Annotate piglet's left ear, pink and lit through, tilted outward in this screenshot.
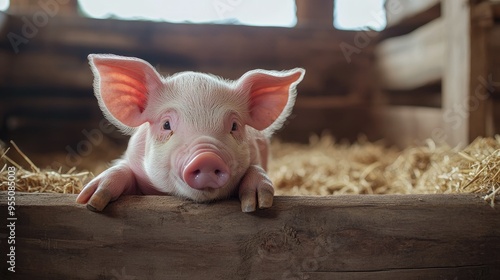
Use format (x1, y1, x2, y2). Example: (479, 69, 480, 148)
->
(88, 54, 162, 130)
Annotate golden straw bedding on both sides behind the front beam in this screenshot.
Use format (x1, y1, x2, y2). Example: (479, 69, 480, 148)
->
(0, 135, 500, 205)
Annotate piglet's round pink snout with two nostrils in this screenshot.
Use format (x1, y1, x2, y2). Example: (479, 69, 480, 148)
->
(182, 152, 230, 190)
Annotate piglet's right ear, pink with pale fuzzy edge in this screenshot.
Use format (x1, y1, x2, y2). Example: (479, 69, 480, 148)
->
(238, 68, 305, 133)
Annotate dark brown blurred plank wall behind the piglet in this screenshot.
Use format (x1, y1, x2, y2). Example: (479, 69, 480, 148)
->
(0, 0, 378, 168)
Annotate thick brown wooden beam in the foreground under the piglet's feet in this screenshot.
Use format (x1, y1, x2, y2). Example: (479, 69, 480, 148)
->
(0, 193, 500, 279)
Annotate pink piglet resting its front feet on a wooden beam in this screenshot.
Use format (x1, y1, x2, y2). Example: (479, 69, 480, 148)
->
(76, 54, 305, 212)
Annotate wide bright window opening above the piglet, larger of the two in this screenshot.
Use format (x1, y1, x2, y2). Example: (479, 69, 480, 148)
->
(78, 0, 297, 27)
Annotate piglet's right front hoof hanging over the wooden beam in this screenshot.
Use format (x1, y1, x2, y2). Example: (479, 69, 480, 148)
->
(239, 166, 274, 213)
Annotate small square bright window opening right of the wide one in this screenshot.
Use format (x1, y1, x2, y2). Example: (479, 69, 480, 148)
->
(333, 0, 387, 31)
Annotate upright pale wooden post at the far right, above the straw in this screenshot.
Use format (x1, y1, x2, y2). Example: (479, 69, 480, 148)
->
(443, 0, 492, 146)
